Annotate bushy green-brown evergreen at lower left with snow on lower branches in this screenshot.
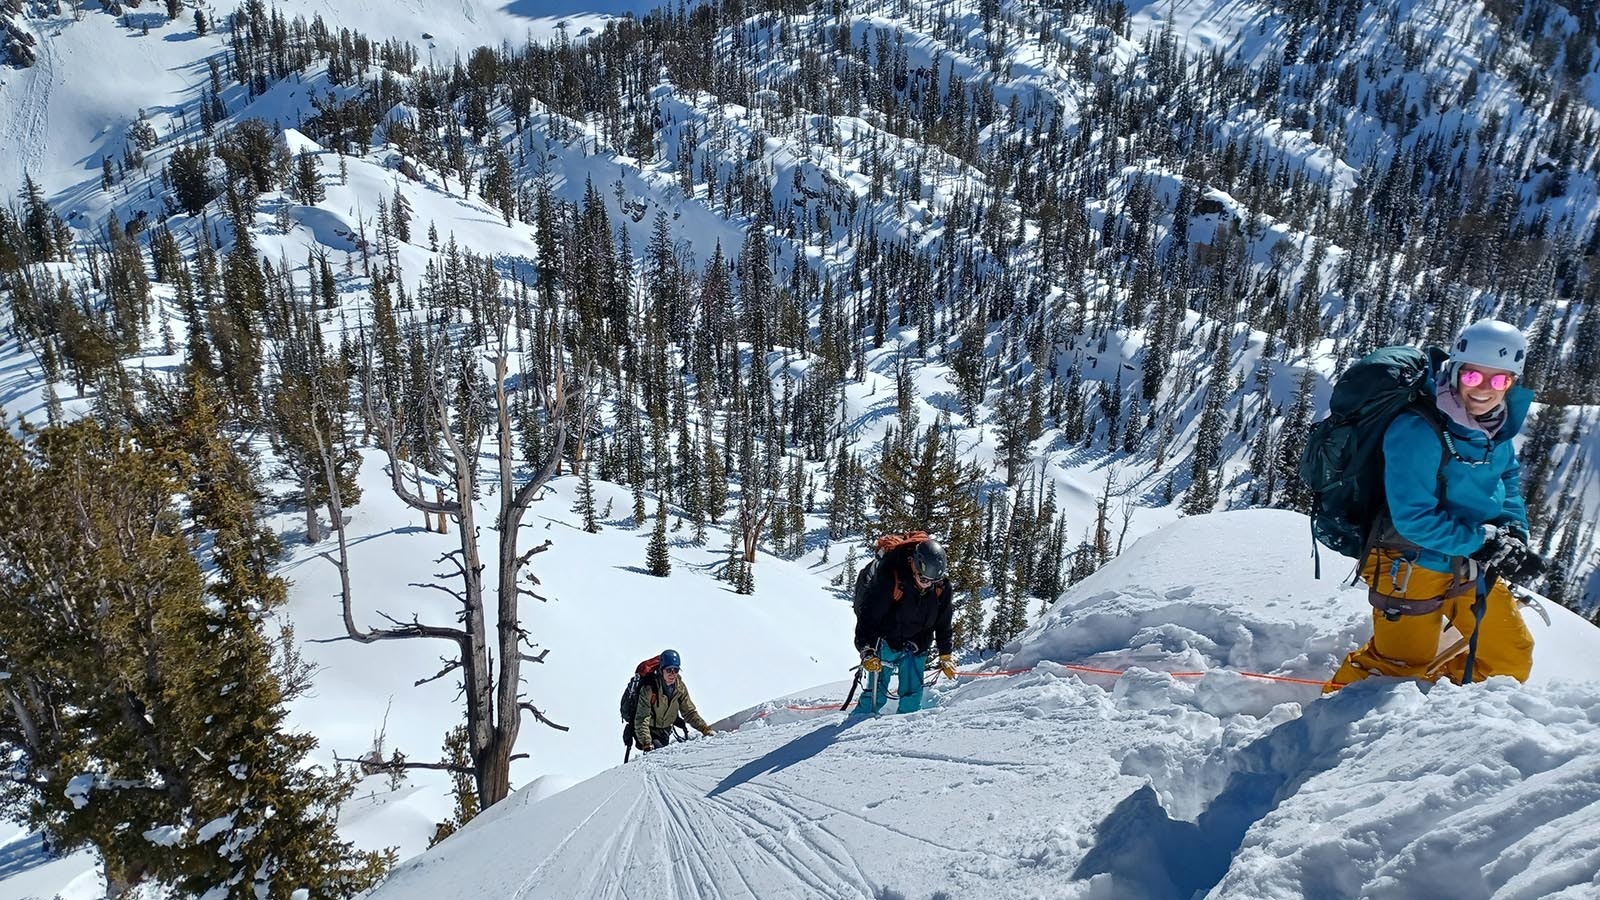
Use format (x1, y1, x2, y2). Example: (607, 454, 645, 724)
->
(0, 421, 386, 900)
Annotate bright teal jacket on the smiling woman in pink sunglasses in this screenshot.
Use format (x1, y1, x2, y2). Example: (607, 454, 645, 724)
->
(1384, 351, 1533, 572)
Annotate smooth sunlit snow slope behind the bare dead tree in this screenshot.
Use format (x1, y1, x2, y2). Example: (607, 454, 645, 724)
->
(283, 453, 856, 813)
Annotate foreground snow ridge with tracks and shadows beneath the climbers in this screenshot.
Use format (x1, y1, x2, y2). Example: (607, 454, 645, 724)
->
(360, 511, 1600, 900)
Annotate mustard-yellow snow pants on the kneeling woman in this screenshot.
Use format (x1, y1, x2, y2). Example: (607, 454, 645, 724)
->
(1323, 551, 1533, 692)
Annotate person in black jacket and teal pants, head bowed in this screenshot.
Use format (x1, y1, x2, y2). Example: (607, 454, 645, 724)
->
(856, 536, 955, 714)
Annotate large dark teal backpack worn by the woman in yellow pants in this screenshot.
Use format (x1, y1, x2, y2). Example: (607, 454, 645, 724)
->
(1299, 348, 1448, 566)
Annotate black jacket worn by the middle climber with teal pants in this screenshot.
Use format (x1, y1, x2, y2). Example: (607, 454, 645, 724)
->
(856, 544, 955, 653)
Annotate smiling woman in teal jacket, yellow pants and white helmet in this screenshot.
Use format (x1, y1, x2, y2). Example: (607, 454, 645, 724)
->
(1330, 319, 1542, 687)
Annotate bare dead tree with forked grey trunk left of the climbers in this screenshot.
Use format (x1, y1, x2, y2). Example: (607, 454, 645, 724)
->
(312, 309, 592, 809)
